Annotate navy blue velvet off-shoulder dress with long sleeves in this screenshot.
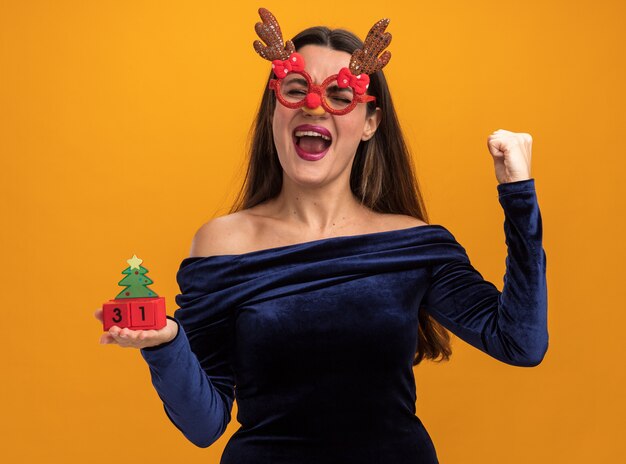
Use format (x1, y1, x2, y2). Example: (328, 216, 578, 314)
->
(141, 179, 548, 464)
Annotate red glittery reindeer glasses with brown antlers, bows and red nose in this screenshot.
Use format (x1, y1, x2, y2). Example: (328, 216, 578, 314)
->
(254, 8, 391, 115)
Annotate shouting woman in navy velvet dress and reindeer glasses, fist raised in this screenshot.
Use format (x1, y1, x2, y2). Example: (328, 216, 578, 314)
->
(94, 10, 548, 464)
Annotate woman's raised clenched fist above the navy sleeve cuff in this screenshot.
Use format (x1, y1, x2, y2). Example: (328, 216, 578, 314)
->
(487, 129, 533, 184)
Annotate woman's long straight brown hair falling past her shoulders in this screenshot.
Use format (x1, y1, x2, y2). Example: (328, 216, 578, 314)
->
(230, 27, 452, 365)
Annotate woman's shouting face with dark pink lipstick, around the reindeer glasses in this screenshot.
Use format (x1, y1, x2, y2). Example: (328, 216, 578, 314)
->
(272, 45, 380, 186)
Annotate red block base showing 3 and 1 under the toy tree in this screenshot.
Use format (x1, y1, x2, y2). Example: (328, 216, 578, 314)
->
(102, 297, 167, 331)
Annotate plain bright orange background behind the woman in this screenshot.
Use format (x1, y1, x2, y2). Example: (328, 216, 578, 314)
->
(0, 0, 626, 464)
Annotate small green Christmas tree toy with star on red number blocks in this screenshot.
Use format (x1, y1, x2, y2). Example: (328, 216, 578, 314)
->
(102, 255, 166, 331)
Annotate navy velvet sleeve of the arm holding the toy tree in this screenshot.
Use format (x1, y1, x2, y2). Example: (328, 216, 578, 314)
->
(141, 270, 235, 448)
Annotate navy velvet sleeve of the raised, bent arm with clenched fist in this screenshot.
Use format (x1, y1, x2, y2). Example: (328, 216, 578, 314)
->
(423, 179, 548, 367)
